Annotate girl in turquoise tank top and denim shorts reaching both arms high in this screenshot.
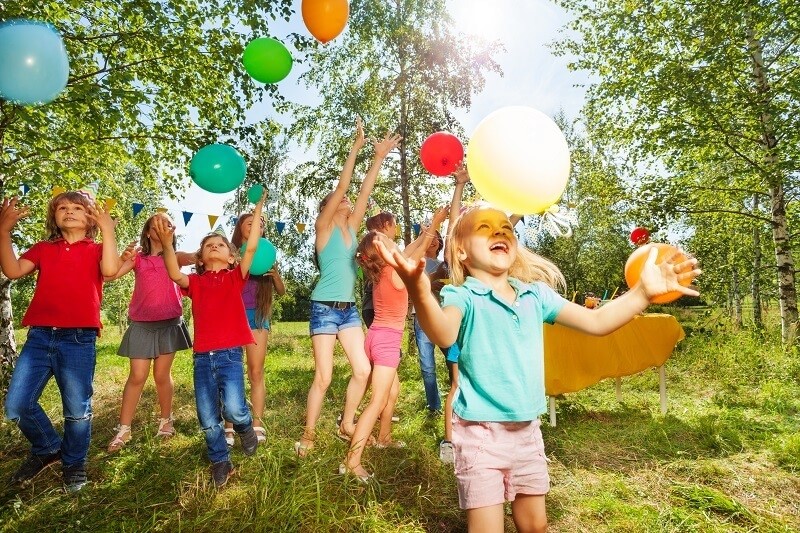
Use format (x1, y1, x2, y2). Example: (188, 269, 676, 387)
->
(294, 119, 401, 457)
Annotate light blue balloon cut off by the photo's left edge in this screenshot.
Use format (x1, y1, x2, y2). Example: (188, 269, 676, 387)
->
(0, 20, 69, 105)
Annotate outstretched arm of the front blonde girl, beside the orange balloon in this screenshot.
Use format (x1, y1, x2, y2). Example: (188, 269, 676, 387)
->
(556, 246, 701, 335)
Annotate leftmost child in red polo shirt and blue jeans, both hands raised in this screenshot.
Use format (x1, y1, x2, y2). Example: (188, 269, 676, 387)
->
(0, 191, 121, 492)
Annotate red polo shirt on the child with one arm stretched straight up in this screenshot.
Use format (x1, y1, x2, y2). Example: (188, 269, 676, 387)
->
(181, 265, 255, 352)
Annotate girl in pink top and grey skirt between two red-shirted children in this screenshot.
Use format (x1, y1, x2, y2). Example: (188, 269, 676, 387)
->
(108, 213, 194, 453)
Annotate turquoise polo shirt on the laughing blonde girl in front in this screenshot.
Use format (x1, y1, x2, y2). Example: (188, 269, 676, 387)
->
(442, 277, 567, 422)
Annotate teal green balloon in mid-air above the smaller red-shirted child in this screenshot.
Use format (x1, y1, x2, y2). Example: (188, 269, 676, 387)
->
(189, 144, 247, 193)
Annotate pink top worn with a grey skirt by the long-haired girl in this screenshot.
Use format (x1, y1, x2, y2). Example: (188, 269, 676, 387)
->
(128, 254, 183, 322)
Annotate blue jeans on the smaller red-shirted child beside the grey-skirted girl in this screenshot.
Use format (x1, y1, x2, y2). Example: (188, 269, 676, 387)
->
(194, 347, 253, 463)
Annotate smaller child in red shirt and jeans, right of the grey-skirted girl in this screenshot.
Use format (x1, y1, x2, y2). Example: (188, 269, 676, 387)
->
(153, 196, 264, 488)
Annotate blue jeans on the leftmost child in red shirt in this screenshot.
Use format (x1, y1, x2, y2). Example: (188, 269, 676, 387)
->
(5, 327, 97, 467)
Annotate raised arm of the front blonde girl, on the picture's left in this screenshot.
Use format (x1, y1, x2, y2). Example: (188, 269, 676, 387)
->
(375, 240, 461, 346)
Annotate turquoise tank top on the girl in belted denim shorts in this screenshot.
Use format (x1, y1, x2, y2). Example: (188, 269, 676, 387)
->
(311, 227, 358, 302)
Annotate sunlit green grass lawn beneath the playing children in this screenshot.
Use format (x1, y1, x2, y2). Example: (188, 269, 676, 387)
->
(0, 313, 800, 532)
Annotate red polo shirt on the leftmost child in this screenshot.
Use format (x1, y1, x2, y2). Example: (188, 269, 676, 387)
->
(20, 238, 103, 329)
